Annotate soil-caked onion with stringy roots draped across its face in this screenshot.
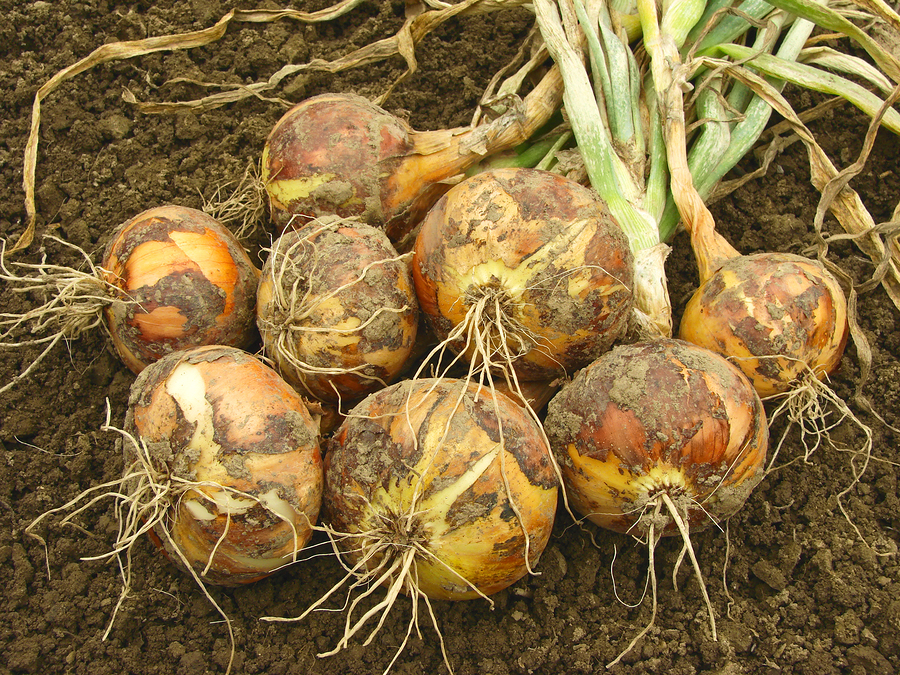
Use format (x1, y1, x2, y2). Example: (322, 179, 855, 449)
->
(256, 221, 419, 403)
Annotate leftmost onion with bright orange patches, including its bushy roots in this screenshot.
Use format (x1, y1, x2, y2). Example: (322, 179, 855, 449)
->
(0, 205, 259, 391)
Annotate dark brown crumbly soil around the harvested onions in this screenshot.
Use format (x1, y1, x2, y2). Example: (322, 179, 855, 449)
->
(0, 0, 900, 675)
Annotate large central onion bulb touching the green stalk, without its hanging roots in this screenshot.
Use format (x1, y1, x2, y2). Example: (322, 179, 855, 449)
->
(413, 169, 634, 380)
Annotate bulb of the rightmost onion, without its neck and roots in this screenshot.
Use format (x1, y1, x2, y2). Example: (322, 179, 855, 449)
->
(679, 253, 849, 398)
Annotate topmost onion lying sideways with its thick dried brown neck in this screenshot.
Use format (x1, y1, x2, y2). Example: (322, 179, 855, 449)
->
(261, 83, 560, 242)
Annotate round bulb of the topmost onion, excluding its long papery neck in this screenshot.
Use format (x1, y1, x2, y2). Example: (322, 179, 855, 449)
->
(262, 94, 412, 240)
